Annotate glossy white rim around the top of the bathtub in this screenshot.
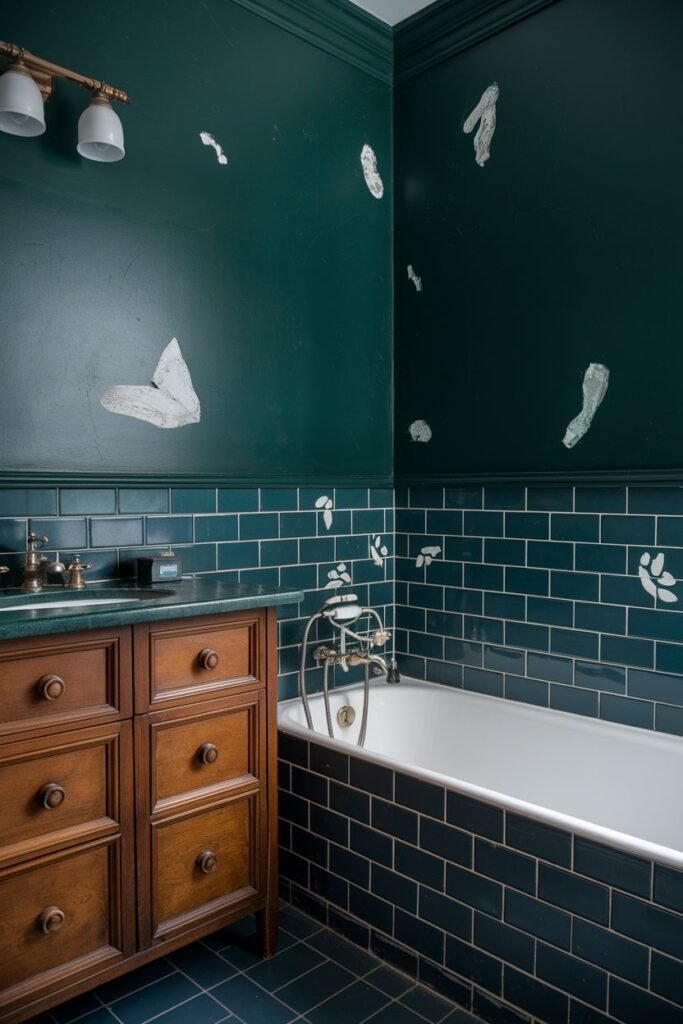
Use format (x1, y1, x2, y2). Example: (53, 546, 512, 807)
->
(278, 676, 683, 870)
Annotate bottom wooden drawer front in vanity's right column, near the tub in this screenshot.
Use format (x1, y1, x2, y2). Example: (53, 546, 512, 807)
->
(152, 794, 261, 938)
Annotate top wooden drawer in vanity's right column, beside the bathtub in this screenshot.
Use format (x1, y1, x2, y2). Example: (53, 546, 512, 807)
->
(135, 612, 265, 713)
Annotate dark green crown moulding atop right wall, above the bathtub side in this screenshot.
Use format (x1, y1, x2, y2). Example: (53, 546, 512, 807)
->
(394, 0, 555, 83)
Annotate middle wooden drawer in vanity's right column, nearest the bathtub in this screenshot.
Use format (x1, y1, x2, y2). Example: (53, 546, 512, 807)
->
(142, 689, 265, 814)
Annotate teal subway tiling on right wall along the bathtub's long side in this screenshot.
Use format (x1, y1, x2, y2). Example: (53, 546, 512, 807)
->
(396, 486, 683, 735)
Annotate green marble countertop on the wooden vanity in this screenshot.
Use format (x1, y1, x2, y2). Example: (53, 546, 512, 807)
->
(0, 578, 303, 640)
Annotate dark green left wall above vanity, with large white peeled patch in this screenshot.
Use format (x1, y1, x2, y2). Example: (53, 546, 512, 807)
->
(0, 0, 392, 482)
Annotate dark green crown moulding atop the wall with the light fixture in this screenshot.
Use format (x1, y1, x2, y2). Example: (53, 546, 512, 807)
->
(229, 0, 393, 84)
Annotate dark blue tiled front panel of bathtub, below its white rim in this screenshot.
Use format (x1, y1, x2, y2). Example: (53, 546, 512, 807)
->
(281, 733, 683, 1024)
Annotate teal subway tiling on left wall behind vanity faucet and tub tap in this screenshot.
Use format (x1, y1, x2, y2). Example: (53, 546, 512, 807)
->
(0, 487, 394, 696)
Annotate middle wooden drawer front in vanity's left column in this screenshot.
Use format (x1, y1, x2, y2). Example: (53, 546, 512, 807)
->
(0, 722, 132, 863)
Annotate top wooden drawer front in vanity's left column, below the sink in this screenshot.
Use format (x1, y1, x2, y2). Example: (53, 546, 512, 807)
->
(0, 630, 132, 736)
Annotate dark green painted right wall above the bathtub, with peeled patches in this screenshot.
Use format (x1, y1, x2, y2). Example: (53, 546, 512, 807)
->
(394, 0, 683, 479)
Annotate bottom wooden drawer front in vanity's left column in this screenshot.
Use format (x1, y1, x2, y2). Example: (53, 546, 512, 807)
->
(0, 839, 128, 1008)
